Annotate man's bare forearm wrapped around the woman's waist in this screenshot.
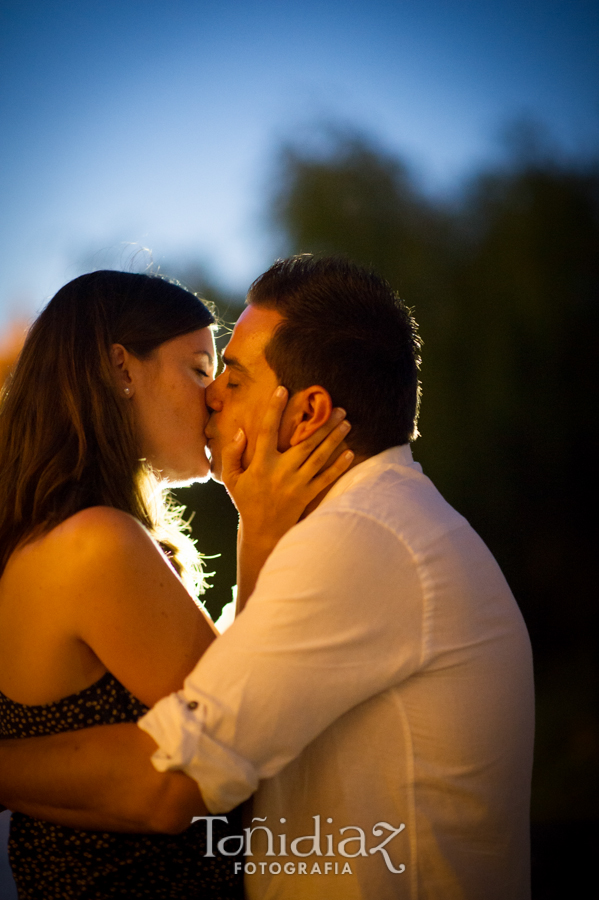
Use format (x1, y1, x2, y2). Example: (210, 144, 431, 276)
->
(0, 723, 209, 833)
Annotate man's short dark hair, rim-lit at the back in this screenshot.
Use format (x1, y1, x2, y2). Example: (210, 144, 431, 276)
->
(247, 254, 421, 456)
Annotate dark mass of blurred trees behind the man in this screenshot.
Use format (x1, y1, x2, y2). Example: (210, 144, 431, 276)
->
(271, 128, 599, 836)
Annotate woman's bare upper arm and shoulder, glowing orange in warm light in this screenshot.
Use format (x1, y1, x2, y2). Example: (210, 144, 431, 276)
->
(30, 507, 216, 706)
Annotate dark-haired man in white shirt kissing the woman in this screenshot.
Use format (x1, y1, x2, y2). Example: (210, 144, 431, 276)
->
(0, 256, 533, 900)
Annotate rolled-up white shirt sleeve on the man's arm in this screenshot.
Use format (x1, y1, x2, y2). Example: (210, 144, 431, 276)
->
(139, 507, 423, 813)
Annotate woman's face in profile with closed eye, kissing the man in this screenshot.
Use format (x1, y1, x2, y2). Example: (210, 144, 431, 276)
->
(123, 328, 216, 484)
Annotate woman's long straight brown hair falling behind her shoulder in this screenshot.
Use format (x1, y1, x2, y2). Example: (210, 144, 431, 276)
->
(0, 271, 215, 592)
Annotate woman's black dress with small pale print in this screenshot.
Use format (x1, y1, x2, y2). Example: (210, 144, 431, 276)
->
(0, 672, 243, 900)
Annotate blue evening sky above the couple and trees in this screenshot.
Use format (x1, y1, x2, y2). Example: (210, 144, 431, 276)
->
(0, 0, 599, 320)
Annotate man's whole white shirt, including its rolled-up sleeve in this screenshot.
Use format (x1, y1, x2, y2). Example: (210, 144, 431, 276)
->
(139, 445, 534, 900)
